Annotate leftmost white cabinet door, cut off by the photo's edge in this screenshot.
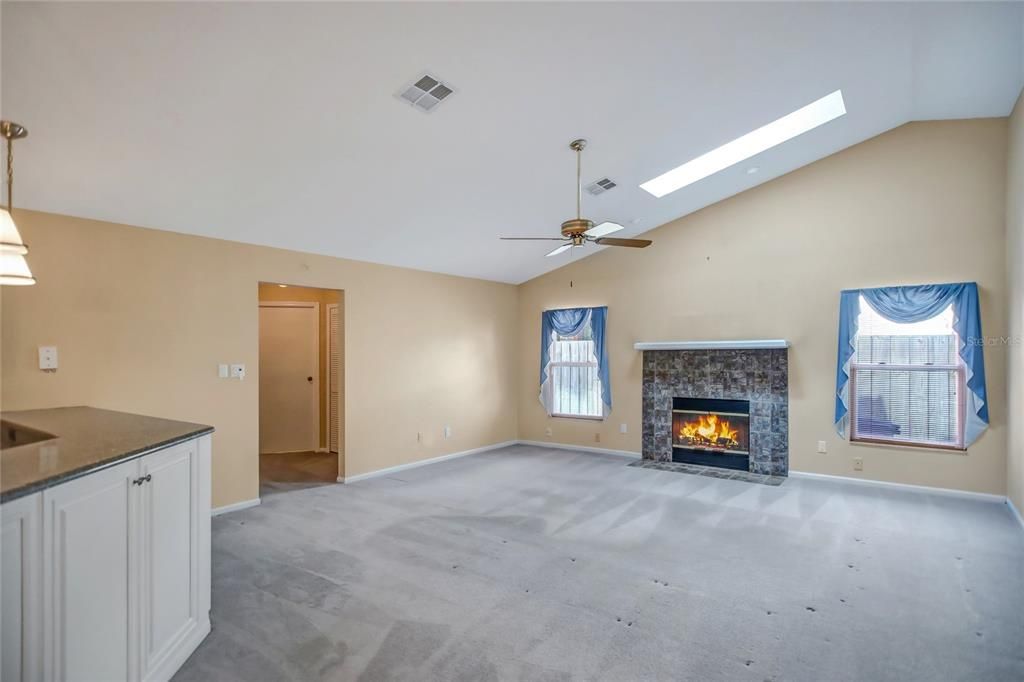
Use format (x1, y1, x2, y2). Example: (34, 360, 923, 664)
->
(0, 493, 43, 682)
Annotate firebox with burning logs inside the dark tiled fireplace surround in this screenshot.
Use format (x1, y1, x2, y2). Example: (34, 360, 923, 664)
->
(672, 397, 751, 471)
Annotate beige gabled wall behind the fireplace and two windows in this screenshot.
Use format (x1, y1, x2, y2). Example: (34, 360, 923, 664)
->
(518, 119, 1008, 494)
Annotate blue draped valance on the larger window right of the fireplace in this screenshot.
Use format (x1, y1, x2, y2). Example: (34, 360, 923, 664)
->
(835, 282, 988, 446)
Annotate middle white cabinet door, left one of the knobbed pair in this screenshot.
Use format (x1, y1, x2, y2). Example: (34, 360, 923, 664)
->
(43, 460, 139, 680)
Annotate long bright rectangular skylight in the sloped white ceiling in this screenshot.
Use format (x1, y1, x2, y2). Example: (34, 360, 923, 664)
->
(640, 90, 846, 199)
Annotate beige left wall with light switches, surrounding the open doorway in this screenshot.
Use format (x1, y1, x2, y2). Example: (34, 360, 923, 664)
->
(0, 210, 517, 506)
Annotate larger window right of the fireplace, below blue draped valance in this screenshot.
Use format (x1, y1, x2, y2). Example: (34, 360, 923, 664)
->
(850, 296, 965, 450)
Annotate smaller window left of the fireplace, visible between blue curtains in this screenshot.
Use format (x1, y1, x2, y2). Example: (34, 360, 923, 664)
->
(549, 323, 604, 419)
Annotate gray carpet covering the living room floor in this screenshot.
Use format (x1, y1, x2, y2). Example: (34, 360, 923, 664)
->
(175, 445, 1024, 682)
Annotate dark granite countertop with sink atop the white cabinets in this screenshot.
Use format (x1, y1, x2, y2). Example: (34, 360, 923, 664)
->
(0, 407, 213, 502)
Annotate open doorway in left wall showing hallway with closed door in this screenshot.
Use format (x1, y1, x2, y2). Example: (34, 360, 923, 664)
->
(259, 283, 344, 494)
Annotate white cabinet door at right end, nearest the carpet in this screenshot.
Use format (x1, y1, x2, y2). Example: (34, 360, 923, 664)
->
(139, 440, 205, 680)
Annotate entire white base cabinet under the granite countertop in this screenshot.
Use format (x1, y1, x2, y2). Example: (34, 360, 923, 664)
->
(0, 435, 210, 682)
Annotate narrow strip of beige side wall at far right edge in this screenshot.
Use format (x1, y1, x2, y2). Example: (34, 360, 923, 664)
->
(1007, 92, 1024, 503)
